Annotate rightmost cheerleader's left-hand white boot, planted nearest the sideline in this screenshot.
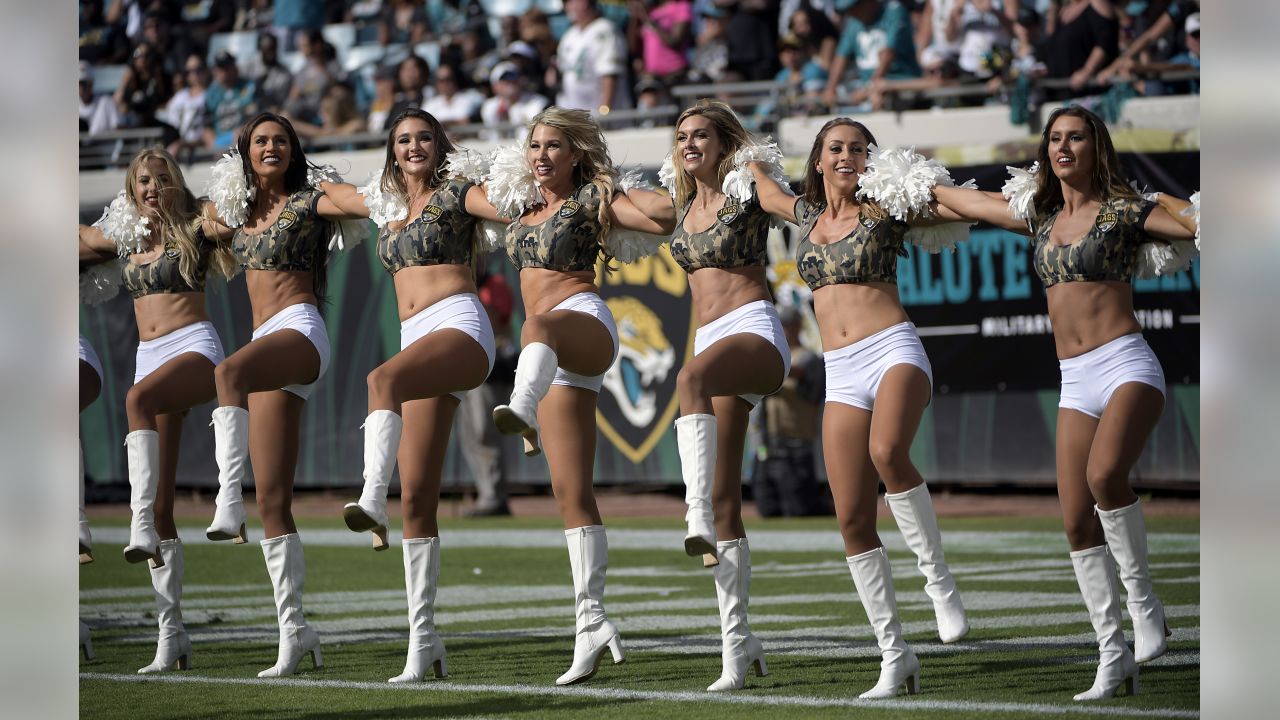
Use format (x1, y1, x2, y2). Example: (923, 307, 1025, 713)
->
(1071, 544, 1138, 701)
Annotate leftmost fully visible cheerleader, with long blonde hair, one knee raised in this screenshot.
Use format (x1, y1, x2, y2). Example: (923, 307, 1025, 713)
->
(79, 149, 233, 674)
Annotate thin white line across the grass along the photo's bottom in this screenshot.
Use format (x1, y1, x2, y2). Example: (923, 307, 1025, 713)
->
(79, 673, 1199, 719)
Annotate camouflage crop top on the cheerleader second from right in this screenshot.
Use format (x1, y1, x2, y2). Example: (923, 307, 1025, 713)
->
(795, 199, 910, 290)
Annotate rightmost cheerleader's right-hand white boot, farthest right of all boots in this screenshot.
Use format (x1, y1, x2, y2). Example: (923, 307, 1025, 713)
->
(1097, 500, 1170, 662)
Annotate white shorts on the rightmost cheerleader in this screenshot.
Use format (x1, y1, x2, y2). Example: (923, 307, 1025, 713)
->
(1057, 333, 1165, 418)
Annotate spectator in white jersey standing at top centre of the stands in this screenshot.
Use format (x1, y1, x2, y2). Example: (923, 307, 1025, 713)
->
(556, 0, 631, 115)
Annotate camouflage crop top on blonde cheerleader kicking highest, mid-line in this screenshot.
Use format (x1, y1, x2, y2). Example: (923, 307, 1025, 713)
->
(507, 183, 600, 273)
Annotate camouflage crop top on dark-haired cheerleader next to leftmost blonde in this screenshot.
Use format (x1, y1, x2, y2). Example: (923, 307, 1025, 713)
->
(232, 187, 332, 272)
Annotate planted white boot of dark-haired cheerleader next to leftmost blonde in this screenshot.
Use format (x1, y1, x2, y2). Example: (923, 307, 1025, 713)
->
(257, 533, 324, 678)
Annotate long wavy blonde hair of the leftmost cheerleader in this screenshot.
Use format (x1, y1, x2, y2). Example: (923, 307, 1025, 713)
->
(124, 147, 236, 280)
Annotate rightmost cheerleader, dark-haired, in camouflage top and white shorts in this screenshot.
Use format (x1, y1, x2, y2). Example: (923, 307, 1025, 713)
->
(934, 106, 1199, 701)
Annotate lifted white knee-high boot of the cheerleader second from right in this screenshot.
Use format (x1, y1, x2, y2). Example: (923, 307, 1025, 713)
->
(884, 483, 969, 643)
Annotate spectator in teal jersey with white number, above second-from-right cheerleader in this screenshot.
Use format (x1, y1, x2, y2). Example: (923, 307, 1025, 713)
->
(823, 0, 920, 106)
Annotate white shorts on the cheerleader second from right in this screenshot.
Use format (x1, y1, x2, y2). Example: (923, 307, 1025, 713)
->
(822, 323, 933, 410)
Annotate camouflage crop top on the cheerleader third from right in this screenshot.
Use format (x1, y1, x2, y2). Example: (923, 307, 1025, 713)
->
(671, 197, 772, 273)
